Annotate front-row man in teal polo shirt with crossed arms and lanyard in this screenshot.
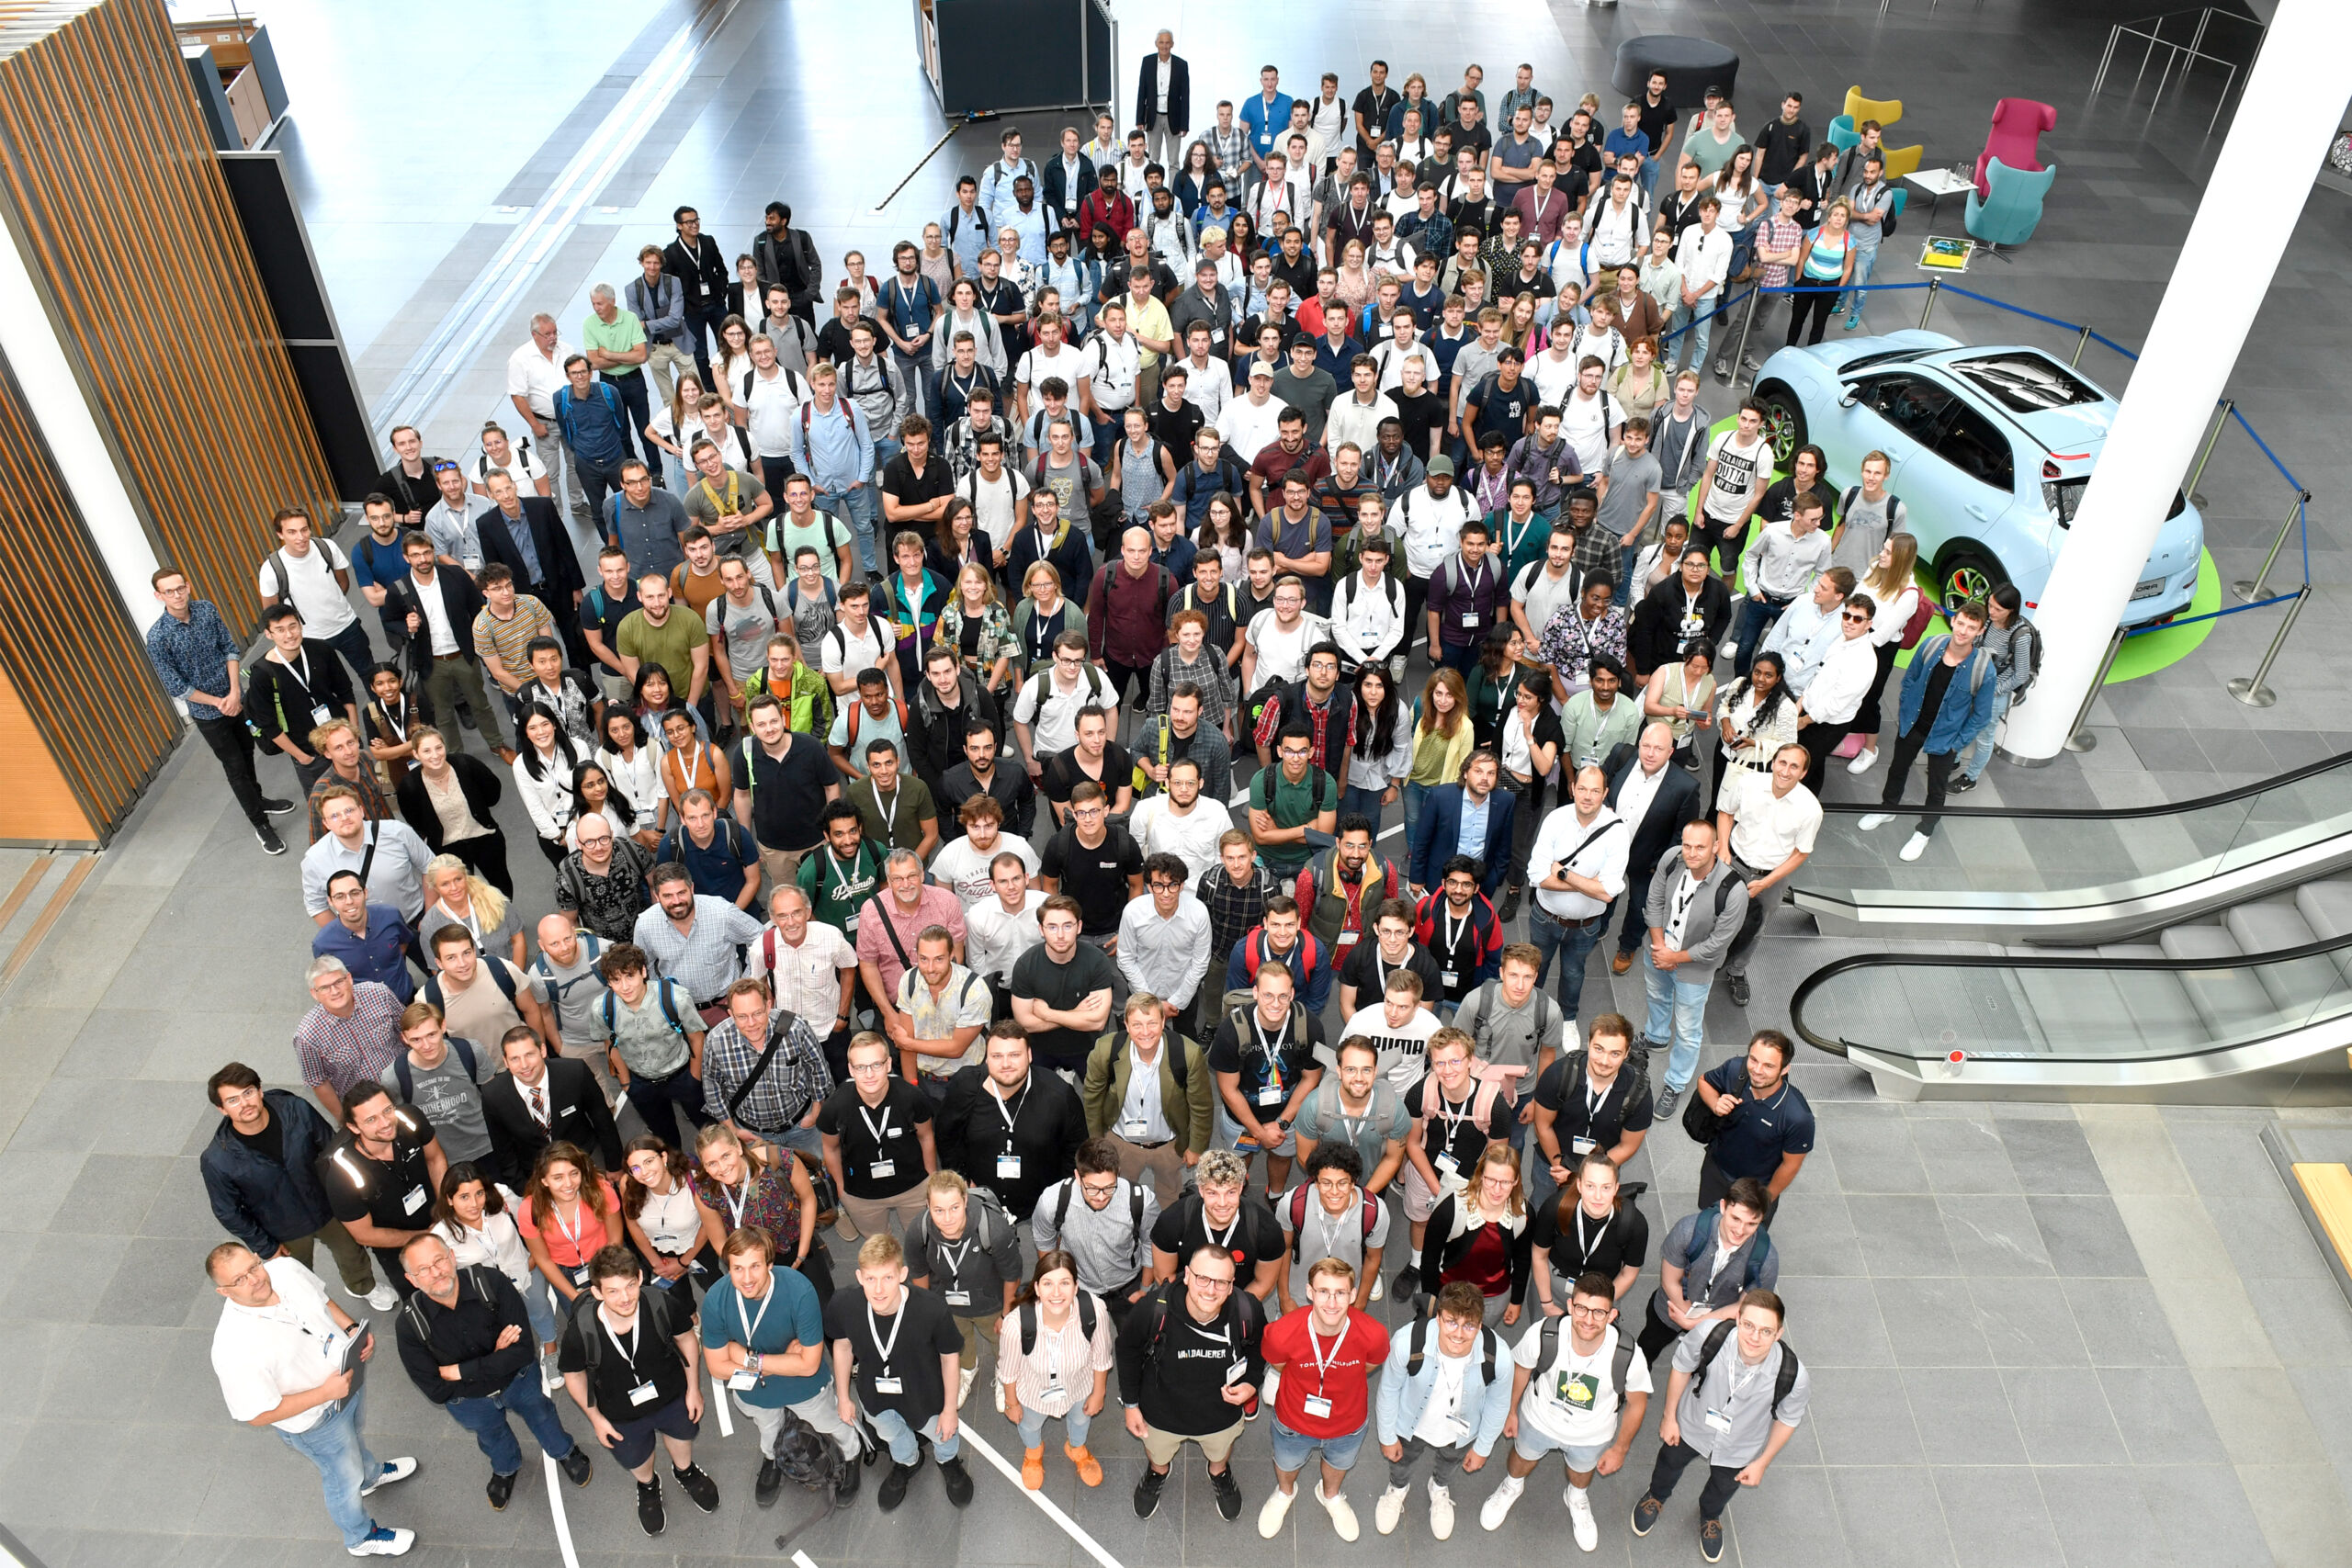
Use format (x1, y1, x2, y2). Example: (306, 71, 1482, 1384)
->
(701, 1224, 864, 1506)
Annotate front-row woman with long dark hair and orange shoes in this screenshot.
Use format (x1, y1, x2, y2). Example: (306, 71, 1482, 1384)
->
(997, 1246, 1117, 1493)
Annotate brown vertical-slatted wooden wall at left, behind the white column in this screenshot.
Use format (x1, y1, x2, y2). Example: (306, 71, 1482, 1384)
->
(0, 0, 336, 837)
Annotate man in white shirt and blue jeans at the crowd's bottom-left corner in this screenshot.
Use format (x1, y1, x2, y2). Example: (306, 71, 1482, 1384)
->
(205, 1241, 416, 1556)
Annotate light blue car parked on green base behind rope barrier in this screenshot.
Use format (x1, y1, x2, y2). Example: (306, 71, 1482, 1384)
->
(1757, 332, 2204, 626)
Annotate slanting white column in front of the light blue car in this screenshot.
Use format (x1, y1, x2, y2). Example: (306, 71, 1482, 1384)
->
(2004, 0, 2352, 761)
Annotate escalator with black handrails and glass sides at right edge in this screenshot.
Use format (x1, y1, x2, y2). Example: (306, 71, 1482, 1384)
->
(1790, 757, 2352, 1105)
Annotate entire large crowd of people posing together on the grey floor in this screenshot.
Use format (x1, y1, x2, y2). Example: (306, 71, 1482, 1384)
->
(148, 33, 2034, 1561)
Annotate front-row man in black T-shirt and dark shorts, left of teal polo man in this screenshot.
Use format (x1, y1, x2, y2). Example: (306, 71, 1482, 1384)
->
(555, 1244, 719, 1535)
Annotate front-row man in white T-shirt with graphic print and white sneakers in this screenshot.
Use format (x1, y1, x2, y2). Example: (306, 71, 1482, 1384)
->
(1477, 1274, 1672, 1551)
